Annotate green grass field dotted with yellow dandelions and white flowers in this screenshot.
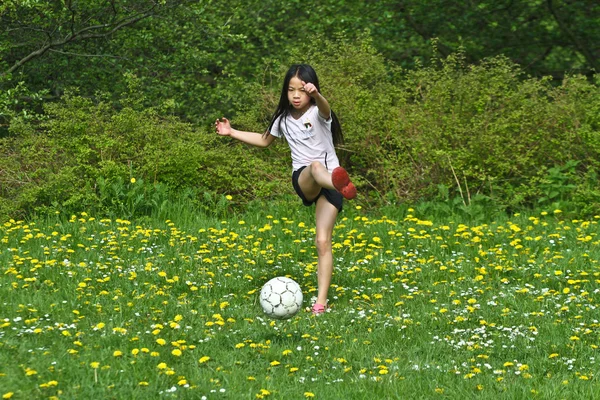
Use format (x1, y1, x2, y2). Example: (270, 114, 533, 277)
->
(0, 205, 600, 399)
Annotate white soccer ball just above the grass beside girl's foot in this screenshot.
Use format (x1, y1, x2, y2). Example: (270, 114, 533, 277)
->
(260, 276, 303, 319)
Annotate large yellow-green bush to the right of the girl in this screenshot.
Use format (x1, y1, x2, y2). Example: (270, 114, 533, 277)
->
(274, 37, 600, 212)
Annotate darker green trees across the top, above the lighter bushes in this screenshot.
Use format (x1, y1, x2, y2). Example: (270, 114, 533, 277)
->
(0, 0, 600, 127)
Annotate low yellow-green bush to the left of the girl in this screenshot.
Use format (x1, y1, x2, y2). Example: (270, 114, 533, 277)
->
(0, 85, 290, 222)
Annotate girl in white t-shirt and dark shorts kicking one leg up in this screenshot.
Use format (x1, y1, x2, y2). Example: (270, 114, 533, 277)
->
(215, 64, 356, 315)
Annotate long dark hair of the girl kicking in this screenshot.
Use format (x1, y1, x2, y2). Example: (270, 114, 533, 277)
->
(269, 64, 344, 145)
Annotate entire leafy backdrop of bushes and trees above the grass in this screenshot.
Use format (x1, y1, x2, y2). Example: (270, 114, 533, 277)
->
(0, 0, 600, 219)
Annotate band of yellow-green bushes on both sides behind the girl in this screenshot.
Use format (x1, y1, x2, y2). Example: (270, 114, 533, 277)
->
(0, 35, 600, 222)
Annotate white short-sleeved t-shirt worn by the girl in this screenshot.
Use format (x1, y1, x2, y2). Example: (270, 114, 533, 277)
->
(269, 104, 340, 172)
